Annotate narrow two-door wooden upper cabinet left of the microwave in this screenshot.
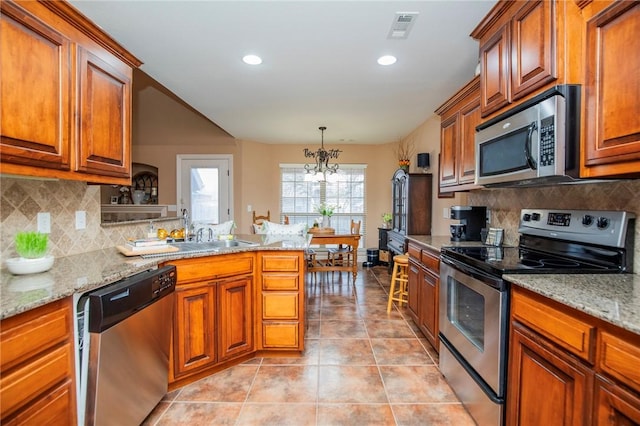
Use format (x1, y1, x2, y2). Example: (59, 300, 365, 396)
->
(436, 77, 480, 192)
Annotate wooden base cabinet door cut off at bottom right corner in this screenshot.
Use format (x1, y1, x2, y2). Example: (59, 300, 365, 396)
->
(593, 378, 640, 426)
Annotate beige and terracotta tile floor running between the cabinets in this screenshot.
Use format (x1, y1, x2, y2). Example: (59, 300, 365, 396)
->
(144, 266, 474, 426)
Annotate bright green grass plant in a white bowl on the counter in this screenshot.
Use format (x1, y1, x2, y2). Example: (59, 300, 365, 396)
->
(6, 231, 54, 275)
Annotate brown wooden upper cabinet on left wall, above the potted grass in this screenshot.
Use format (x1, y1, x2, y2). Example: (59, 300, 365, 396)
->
(0, 0, 141, 184)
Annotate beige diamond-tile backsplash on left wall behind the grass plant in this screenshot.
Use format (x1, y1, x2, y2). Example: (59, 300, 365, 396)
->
(0, 177, 178, 265)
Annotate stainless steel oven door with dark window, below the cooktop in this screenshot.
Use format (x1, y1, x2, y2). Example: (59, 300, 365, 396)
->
(439, 258, 508, 398)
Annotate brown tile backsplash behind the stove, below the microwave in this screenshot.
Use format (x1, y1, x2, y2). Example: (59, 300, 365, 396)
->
(467, 179, 640, 273)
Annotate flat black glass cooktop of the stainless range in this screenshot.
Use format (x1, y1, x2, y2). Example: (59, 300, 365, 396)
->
(442, 246, 619, 274)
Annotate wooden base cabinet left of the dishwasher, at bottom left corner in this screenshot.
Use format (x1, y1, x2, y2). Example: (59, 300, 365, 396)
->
(0, 298, 77, 425)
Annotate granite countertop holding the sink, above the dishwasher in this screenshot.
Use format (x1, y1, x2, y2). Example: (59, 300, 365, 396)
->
(0, 235, 307, 319)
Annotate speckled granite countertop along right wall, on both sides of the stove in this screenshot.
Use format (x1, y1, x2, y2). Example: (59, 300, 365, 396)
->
(407, 235, 640, 334)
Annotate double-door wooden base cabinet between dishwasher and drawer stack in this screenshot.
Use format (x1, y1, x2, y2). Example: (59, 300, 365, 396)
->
(169, 253, 255, 388)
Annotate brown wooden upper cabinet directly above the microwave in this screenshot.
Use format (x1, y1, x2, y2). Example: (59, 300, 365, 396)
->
(471, 0, 581, 118)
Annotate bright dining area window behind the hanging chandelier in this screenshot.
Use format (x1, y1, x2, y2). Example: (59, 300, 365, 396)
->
(280, 164, 367, 235)
